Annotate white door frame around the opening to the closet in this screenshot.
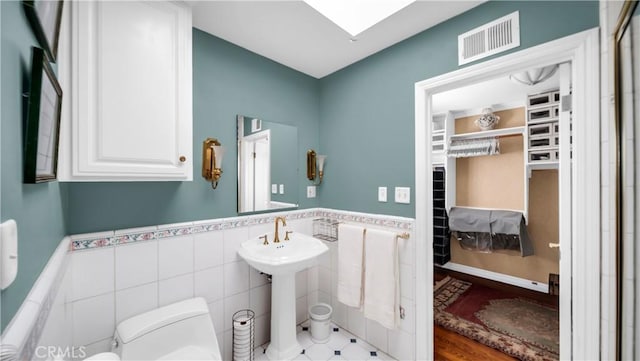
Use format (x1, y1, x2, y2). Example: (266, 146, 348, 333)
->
(415, 28, 601, 360)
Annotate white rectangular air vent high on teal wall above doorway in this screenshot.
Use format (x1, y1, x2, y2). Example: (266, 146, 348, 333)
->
(458, 11, 520, 65)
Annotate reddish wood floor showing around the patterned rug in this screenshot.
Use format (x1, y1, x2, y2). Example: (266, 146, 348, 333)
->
(433, 267, 558, 361)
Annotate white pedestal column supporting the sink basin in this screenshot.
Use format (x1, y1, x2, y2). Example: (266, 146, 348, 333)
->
(267, 272, 302, 360)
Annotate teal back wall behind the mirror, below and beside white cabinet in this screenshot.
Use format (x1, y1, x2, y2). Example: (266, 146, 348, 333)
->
(67, 29, 320, 234)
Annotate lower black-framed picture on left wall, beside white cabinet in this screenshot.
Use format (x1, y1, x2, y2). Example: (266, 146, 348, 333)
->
(24, 47, 62, 183)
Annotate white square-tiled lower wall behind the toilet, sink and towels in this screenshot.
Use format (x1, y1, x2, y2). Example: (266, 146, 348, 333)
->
(28, 210, 415, 359)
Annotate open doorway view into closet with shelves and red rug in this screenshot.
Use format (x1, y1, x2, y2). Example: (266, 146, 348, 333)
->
(432, 63, 571, 359)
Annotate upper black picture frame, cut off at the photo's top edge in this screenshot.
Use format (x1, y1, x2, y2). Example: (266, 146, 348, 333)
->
(22, 0, 63, 63)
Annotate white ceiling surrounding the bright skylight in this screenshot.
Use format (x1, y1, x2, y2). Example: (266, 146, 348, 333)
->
(187, 0, 486, 78)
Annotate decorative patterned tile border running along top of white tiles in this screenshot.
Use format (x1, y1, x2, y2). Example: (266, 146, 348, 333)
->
(69, 208, 415, 252)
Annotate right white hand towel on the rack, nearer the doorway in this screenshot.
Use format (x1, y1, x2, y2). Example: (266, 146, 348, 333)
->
(364, 229, 400, 330)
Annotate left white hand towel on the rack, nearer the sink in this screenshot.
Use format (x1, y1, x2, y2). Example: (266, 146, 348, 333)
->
(338, 223, 364, 308)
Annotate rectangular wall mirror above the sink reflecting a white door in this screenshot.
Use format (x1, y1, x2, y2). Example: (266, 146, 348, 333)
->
(236, 115, 298, 213)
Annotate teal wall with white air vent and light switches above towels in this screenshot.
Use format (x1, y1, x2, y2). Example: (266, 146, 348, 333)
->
(318, 1, 599, 217)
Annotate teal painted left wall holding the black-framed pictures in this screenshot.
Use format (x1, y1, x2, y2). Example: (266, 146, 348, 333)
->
(0, 1, 67, 330)
